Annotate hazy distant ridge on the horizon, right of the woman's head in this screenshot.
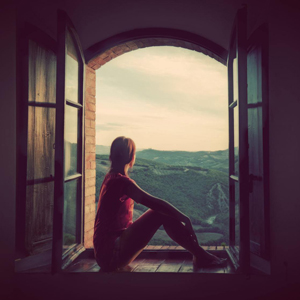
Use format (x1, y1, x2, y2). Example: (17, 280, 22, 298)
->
(136, 149, 228, 173)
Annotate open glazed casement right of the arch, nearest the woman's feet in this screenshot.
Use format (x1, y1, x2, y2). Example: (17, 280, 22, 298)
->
(227, 7, 250, 273)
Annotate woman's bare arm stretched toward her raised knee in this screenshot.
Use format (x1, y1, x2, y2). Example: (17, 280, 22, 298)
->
(126, 182, 189, 223)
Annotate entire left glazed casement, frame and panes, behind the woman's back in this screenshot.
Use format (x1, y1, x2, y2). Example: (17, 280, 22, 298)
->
(52, 11, 85, 272)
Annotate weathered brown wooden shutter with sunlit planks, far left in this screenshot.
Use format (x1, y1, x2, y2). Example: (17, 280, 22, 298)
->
(16, 24, 56, 257)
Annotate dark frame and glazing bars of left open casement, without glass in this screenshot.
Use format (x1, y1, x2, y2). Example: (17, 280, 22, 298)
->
(52, 10, 85, 273)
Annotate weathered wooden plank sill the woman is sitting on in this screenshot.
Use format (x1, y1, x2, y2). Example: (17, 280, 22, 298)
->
(65, 246, 234, 274)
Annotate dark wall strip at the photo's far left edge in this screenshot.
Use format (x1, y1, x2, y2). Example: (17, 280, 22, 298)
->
(0, 5, 16, 299)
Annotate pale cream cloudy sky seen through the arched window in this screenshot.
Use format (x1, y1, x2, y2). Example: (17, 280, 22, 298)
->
(96, 46, 228, 151)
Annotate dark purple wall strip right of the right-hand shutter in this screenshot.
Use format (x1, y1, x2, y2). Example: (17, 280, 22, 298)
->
(269, 1, 300, 277)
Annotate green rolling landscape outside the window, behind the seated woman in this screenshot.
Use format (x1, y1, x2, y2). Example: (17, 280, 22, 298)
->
(96, 145, 233, 245)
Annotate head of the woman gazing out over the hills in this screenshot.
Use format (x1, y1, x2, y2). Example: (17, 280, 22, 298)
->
(109, 136, 135, 173)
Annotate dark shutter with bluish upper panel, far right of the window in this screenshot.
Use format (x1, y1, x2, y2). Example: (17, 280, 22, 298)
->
(247, 25, 270, 273)
